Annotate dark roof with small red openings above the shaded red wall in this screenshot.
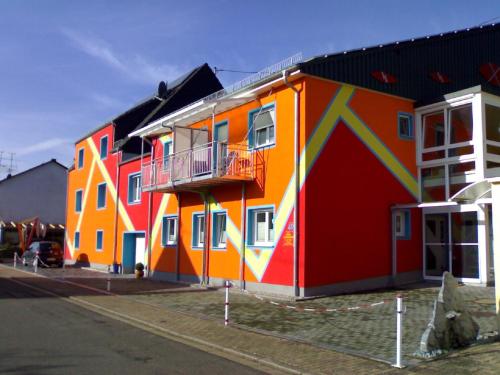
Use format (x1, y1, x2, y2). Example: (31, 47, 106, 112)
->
(298, 24, 500, 104)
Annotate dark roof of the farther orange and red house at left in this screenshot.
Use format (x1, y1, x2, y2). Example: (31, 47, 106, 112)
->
(75, 63, 222, 146)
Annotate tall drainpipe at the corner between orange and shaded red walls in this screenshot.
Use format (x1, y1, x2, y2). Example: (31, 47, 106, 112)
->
(283, 70, 300, 297)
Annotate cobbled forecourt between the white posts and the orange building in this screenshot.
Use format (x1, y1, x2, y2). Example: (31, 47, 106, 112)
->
(1, 262, 500, 372)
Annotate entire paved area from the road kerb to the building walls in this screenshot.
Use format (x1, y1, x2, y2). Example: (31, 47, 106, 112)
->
(0, 265, 500, 375)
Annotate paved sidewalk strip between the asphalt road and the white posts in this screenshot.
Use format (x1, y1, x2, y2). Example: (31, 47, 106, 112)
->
(0, 267, 500, 374)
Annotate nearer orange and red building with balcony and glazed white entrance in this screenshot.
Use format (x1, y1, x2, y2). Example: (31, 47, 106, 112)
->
(68, 25, 500, 296)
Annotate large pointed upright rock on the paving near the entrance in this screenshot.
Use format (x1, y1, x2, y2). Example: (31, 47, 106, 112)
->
(420, 272, 479, 356)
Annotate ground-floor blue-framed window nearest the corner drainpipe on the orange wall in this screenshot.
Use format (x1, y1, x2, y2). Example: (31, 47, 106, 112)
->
(248, 208, 274, 246)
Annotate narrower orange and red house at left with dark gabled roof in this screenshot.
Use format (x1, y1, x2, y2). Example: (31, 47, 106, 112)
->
(65, 64, 222, 272)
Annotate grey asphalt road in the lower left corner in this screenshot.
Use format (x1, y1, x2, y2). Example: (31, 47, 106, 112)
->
(0, 278, 264, 375)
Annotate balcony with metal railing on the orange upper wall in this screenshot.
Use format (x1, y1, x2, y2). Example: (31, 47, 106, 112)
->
(142, 142, 255, 193)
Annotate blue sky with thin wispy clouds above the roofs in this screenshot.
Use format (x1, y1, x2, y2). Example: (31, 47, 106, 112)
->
(0, 0, 500, 177)
